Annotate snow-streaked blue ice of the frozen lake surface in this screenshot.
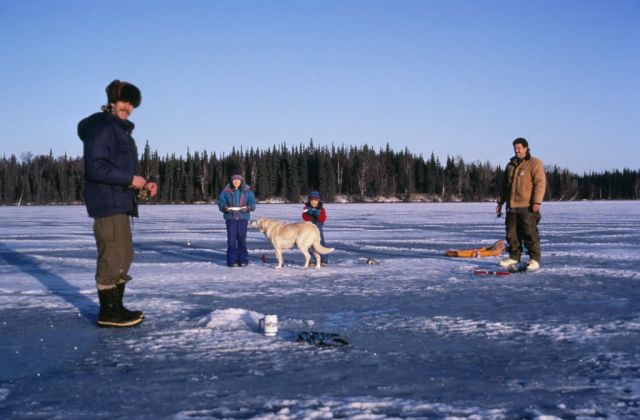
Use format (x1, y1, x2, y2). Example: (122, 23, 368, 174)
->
(0, 201, 640, 419)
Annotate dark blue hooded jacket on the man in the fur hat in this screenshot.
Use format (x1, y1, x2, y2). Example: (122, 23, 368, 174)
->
(78, 111, 138, 217)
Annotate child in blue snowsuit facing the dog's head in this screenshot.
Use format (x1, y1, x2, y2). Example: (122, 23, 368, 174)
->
(218, 174, 256, 267)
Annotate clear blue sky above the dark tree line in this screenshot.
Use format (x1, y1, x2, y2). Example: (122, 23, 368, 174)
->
(0, 0, 640, 173)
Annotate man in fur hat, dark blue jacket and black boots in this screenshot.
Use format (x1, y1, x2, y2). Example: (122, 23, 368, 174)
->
(78, 80, 158, 327)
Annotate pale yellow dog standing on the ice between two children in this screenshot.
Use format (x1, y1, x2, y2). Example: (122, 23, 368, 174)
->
(251, 217, 333, 269)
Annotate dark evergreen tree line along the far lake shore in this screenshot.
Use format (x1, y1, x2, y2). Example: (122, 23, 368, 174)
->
(0, 140, 640, 205)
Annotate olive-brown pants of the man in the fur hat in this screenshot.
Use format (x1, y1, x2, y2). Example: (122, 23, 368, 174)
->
(93, 214, 133, 290)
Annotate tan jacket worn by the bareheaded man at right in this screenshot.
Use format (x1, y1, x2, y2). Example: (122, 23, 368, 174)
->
(500, 156, 547, 209)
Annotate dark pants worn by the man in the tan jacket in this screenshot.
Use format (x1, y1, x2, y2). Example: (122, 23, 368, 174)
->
(506, 209, 542, 262)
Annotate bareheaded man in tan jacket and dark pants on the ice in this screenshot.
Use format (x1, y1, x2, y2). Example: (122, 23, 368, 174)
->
(496, 137, 546, 271)
